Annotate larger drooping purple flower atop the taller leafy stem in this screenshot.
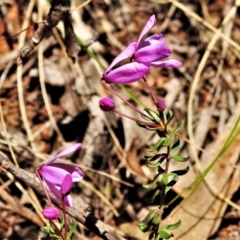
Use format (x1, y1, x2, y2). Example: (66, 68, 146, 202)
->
(103, 15, 182, 84)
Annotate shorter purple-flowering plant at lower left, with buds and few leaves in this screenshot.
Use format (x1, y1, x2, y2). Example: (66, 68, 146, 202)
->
(36, 143, 83, 240)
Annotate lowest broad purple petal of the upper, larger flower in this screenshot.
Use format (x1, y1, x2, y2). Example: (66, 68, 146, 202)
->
(103, 62, 149, 84)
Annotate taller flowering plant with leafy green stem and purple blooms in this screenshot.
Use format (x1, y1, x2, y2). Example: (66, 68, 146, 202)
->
(99, 15, 189, 240)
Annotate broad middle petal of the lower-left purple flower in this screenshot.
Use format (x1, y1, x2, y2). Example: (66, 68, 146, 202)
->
(40, 163, 83, 186)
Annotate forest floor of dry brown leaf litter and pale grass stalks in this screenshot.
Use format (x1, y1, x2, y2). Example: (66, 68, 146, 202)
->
(0, 0, 240, 240)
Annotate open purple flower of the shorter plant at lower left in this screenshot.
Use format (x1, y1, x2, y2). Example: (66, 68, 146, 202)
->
(39, 143, 83, 207)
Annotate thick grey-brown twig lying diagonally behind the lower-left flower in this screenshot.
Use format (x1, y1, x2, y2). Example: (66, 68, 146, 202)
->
(0, 152, 126, 240)
